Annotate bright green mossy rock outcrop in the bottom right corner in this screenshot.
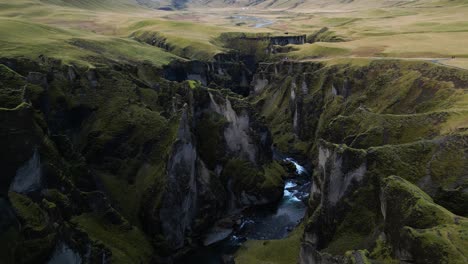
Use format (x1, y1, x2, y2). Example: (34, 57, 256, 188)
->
(380, 176, 468, 263)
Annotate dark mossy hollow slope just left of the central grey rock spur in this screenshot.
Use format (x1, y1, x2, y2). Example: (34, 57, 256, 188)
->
(81, 94, 177, 225)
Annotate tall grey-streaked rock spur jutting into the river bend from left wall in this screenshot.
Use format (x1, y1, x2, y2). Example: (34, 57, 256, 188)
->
(159, 90, 282, 250)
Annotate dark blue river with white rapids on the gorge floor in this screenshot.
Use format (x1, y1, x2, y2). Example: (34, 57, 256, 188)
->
(176, 157, 311, 264)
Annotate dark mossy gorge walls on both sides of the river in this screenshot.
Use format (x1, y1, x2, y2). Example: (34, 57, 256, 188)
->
(0, 42, 468, 264)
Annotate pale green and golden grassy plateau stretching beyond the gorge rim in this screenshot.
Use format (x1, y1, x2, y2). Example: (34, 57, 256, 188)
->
(0, 0, 468, 68)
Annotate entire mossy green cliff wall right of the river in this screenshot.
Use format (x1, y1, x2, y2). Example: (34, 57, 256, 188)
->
(252, 61, 468, 263)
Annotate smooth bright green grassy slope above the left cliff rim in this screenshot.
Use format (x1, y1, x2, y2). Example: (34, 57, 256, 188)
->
(0, 18, 176, 67)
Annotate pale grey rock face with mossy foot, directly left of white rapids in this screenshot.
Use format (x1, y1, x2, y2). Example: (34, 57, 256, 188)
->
(209, 92, 282, 209)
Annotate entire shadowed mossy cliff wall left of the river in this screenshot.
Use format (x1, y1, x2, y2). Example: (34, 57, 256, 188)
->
(0, 55, 285, 263)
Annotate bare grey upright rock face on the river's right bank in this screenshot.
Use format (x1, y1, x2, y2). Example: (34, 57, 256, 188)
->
(300, 141, 367, 264)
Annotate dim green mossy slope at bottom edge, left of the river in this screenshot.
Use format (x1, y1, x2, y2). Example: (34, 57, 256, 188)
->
(72, 214, 153, 263)
